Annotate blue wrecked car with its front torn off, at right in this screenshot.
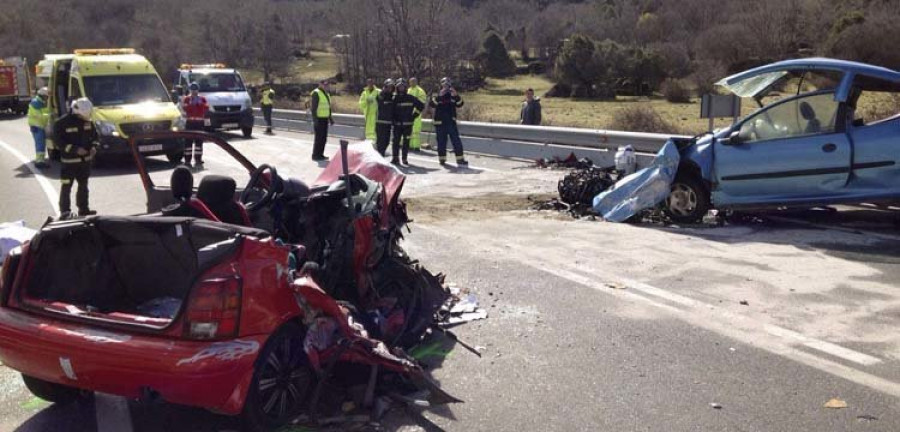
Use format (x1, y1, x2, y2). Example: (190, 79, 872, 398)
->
(664, 58, 900, 222)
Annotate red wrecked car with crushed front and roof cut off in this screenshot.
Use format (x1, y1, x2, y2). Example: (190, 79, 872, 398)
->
(0, 132, 457, 430)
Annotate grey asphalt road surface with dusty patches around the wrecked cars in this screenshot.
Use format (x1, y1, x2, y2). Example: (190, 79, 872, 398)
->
(0, 115, 900, 431)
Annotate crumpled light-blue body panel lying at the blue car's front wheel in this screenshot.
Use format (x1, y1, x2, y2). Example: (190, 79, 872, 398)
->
(594, 140, 681, 222)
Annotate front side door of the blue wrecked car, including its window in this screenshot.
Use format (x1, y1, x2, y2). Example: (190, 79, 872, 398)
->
(713, 91, 852, 205)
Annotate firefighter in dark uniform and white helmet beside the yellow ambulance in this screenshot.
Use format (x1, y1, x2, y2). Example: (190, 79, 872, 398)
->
(53, 98, 98, 220)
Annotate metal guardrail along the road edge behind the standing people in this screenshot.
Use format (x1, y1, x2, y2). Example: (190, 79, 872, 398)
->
(256, 109, 690, 153)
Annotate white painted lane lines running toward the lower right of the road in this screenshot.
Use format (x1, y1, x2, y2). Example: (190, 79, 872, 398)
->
(418, 225, 900, 397)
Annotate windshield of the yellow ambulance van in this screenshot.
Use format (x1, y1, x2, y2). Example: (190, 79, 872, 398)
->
(84, 74, 171, 106)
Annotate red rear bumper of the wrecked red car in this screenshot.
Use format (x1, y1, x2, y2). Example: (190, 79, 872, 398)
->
(0, 308, 265, 415)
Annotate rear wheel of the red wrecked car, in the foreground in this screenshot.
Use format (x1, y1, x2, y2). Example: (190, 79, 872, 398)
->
(242, 323, 316, 431)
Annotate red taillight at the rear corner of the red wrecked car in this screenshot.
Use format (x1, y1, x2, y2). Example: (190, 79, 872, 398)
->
(184, 277, 241, 339)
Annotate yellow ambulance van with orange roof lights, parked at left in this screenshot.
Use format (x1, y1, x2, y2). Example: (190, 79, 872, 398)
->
(37, 48, 184, 163)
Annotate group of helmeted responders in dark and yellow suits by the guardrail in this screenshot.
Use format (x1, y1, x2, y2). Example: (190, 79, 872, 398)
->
(359, 78, 469, 166)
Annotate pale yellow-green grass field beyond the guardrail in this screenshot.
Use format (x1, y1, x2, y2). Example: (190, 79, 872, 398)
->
(242, 51, 896, 135)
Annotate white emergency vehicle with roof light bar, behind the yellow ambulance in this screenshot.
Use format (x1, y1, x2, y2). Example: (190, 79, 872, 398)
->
(173, 63, 254, 138)
